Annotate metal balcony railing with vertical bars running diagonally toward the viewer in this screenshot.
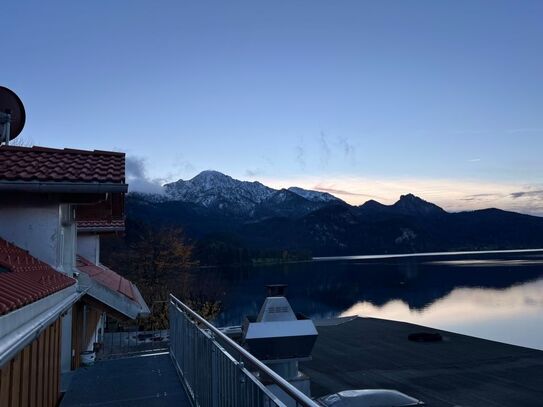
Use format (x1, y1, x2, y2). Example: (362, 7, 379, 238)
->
(170, 295, 318, 407)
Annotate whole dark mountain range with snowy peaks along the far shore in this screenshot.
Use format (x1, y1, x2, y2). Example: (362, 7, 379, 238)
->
(127, 171, 543, 255)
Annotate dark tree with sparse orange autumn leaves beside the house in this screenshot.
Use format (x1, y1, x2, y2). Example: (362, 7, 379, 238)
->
(102, 220, 220, 330)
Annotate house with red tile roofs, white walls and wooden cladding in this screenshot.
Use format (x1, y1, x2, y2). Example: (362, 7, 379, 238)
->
(0, 146, 149, 407)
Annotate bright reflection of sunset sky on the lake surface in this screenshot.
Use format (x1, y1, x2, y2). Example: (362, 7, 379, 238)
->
(341, 279, 543, 349)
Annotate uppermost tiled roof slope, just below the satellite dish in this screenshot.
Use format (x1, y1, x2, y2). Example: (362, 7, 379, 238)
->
(0, 146, 125, 183)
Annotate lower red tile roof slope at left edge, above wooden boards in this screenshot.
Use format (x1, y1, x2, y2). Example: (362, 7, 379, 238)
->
(0, 238, 76, 315)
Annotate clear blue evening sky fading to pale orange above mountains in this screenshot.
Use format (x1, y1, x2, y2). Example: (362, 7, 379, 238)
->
(0, 0, 543, 216)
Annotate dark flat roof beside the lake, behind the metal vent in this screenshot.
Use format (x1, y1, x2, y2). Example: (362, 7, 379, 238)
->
(300, 318, 543, 407)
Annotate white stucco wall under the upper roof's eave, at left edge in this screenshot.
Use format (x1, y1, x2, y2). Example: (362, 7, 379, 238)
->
(0, 202, 62, 268)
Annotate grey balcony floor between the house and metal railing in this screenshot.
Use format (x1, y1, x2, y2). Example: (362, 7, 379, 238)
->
(60, 353, 190, 407)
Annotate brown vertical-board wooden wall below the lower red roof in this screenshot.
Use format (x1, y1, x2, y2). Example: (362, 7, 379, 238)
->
(0, 319, 61, 407)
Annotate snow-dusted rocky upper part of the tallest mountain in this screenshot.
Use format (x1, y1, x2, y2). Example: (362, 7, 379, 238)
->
(158, 170, 343, 216)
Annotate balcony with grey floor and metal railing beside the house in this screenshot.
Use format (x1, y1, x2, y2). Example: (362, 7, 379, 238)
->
(61, 296, 318, 407)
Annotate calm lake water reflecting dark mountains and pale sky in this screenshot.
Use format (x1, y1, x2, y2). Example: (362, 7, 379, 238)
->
(207, 251, 543, 349)
